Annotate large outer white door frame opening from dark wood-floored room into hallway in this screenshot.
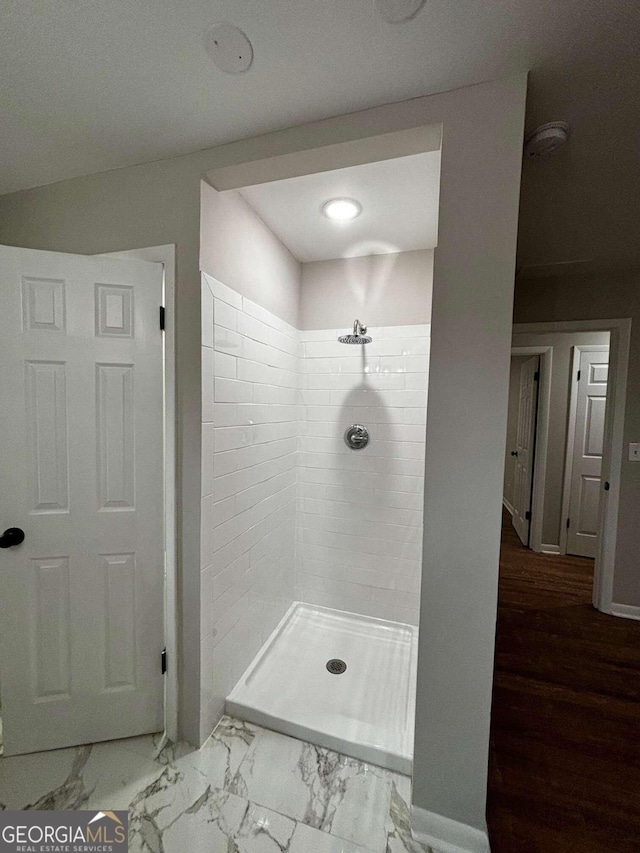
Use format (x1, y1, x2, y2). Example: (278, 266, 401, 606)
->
(513, 318, 631, 616)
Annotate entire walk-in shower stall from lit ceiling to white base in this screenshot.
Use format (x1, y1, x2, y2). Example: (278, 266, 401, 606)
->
(201, 146, 439, 774)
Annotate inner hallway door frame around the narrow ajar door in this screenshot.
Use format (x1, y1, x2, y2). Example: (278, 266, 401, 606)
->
(511, 344, 553, 553)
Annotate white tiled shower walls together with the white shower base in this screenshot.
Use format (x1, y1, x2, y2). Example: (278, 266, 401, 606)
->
(203, 276, 429, 773)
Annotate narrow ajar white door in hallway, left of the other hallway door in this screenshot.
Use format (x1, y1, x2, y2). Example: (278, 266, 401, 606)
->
(511, 355, 540, 546)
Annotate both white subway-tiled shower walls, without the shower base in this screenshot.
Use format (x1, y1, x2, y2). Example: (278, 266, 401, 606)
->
(201, 275, 430, 737)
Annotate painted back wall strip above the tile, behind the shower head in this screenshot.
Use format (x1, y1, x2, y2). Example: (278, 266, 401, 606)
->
(300, 250, 437, 329)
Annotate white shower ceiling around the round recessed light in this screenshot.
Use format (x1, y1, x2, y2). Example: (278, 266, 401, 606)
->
(241, 151, 440, 262)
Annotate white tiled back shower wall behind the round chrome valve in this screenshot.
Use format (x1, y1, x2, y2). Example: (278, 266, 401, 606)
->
(297, 322, 429, 625)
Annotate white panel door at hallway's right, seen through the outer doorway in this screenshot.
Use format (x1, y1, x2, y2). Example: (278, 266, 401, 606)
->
(567, 350, 609, 557)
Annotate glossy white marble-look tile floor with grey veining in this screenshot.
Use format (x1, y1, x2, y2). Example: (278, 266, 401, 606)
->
(0, 717, 433, 853)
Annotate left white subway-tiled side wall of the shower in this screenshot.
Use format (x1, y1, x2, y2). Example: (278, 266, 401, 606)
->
(200, 275, 301, 741)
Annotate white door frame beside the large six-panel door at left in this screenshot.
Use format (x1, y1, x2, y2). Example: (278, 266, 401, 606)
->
(100, 243, 178, 751)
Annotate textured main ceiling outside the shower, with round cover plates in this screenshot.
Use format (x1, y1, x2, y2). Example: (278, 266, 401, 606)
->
(0, 0, 640, 269)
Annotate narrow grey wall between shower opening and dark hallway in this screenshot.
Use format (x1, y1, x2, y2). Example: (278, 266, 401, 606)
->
(412, 77, 526, 850)
